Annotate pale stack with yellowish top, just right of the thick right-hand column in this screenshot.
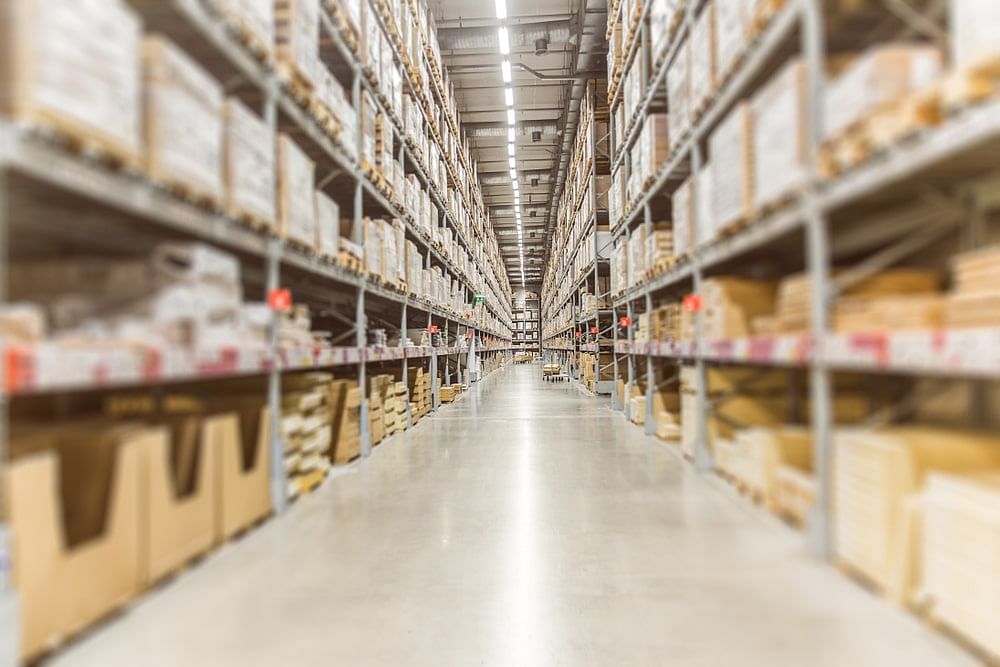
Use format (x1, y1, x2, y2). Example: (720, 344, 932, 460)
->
(833, 426, 1000, 604)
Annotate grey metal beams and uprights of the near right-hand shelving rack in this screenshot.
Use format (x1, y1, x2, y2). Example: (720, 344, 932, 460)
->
(600, 0, 1000, 559)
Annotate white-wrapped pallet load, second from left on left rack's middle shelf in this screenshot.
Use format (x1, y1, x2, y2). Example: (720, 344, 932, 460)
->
(143, 35, 223, 202)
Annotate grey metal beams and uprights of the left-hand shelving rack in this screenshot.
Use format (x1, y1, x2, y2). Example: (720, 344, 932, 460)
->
(0, 0, 512, 652)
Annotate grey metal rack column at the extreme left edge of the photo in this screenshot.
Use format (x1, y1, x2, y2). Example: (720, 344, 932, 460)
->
(0, 171, 20, 665)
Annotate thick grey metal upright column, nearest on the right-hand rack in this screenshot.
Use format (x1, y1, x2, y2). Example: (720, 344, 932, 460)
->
(801, 0, 834, 558)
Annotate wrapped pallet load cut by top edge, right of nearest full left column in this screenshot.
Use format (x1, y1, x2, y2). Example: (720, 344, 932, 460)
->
(274, 0, 324, 91)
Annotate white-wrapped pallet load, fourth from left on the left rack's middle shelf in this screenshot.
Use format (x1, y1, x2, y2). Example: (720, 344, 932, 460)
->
(278, 134, 316, 248)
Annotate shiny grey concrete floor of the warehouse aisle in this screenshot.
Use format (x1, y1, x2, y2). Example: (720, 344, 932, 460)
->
(51, 366, 978, 667)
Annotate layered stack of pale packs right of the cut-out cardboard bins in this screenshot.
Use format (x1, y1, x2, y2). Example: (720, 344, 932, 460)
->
(281, 373, 333, 498)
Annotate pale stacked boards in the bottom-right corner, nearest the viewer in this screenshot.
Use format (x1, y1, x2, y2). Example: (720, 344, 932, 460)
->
(920, 469, 1000, 660)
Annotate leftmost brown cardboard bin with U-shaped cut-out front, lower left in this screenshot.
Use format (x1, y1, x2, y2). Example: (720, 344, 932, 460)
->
(5, 422, 155, 659)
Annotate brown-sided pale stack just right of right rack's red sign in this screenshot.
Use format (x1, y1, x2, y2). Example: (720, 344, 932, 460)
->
(702, 277, 775, 340)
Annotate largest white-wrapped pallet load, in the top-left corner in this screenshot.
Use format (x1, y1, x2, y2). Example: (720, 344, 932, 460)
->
(0, 0, 142, 166)
